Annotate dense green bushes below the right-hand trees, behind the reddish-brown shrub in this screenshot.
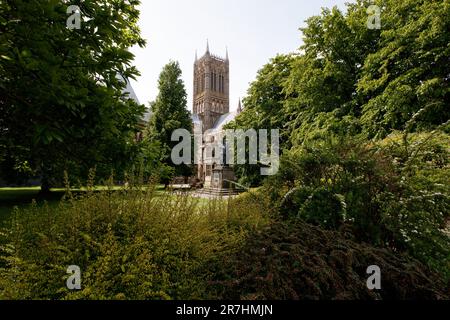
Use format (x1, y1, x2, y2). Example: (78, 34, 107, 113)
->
(266, 132, 450, 276)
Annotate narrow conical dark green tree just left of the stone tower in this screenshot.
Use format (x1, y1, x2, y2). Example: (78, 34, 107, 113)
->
(147, 62, 192, 183)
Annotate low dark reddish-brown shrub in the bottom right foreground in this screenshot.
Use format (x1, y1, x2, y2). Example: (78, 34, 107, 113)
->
(210, 221, 450, 300)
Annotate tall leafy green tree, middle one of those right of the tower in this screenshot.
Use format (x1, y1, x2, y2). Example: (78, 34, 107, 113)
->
(284, 1, 380, 145)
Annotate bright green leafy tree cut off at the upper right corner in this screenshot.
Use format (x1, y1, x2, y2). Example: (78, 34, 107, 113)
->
(358, 0, 450, 138)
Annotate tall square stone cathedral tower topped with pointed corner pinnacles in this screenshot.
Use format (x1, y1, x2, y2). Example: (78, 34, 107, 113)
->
(193, 43, 230, 130)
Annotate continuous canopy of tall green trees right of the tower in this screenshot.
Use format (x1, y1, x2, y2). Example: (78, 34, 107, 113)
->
(230, 0, 450, 185)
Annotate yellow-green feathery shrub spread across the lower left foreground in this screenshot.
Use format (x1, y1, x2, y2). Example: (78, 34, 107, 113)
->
(0, 181, 268, 299)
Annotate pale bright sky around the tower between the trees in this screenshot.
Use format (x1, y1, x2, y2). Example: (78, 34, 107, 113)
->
(131, 0, 351, 111)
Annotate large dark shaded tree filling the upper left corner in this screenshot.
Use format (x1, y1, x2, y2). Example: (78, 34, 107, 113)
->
(0, 0, 145, 189)
